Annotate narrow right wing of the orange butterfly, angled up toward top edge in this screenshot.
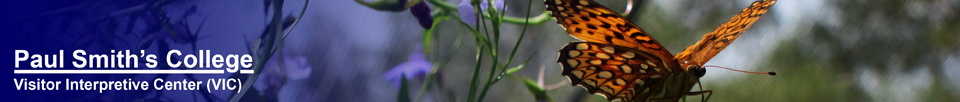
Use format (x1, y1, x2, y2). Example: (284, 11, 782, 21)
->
(676, 0, 777, 66)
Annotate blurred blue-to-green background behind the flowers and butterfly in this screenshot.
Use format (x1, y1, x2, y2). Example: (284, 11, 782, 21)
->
(3, 0, 960, 102)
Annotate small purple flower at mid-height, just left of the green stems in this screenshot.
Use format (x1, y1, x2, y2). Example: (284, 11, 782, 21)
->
(383, 51, 431, 87)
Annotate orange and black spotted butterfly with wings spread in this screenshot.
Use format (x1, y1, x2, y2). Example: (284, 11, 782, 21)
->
(544, 0, 776, 102)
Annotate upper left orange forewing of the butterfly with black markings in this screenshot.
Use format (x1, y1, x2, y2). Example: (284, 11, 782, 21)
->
(544, 0, 673, 57)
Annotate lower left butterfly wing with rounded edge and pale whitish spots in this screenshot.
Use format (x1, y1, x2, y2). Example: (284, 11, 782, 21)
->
(557, 42, 670, 101)
